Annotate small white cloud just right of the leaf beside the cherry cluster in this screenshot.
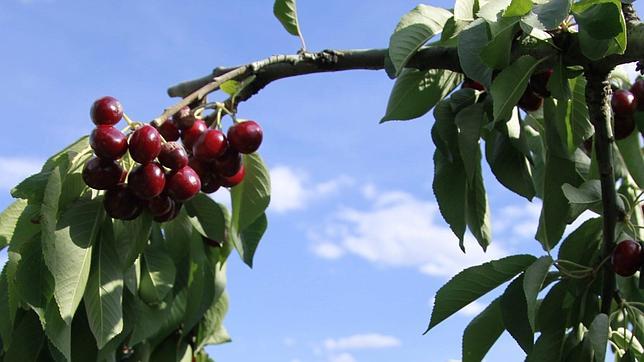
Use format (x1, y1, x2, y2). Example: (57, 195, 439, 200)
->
(270, 166, 353, 212)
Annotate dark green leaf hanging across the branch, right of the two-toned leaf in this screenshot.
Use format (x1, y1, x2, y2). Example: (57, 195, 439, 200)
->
(457, 19, 492, 89)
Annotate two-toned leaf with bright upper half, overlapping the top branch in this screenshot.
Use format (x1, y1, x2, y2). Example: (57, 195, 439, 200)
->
(389, 4, 452, 75)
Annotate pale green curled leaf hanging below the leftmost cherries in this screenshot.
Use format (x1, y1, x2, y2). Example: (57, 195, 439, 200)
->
(41, 182, 104, 324)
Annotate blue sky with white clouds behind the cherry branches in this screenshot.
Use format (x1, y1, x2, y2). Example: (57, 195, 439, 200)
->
(0, 0, 639, 362)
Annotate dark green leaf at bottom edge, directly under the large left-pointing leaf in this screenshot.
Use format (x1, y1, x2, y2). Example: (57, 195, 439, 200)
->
(463, 298, 505, 362)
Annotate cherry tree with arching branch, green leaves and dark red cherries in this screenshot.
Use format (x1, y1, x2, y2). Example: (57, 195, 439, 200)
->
(0, 0, 644, 361)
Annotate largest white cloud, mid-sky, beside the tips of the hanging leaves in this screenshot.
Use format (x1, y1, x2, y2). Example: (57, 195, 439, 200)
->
(309, 186, 508, 276)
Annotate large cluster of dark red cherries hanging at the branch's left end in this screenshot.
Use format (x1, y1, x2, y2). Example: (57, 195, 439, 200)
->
(83, 97, 263, 222)
